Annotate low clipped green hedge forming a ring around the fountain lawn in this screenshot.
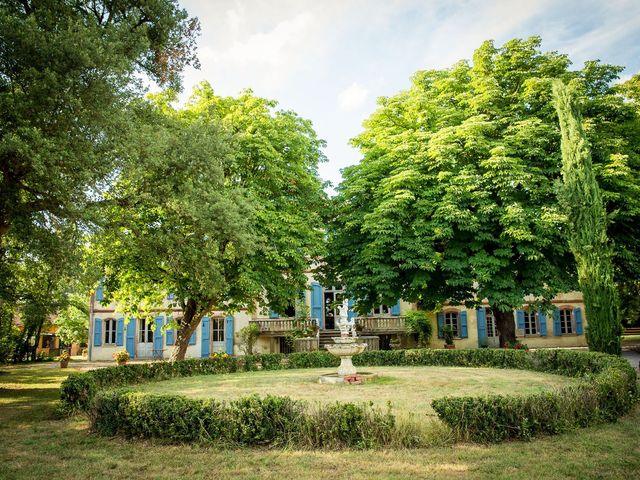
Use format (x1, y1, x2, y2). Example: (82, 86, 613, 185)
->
(61, 349, 638, 448)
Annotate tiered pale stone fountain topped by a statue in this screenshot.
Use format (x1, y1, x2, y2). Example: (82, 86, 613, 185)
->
(320, 300, 375, 383)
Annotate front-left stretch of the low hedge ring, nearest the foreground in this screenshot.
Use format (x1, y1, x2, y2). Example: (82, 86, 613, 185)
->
(91, 390, 395, 448)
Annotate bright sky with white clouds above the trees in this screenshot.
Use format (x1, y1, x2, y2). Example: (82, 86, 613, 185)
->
(181, 0, 640, 192)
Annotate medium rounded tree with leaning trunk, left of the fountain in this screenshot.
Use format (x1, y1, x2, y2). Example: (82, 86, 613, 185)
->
(95, 83, 325, 360)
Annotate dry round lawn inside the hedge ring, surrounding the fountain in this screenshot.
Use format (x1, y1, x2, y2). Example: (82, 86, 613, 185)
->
(137, 367, 575, 414)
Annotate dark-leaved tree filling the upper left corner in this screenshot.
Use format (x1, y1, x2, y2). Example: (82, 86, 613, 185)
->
(0, 0, 199, 338)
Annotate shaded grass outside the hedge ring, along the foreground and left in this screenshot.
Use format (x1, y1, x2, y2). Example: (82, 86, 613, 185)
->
(0, 366, 640, 480)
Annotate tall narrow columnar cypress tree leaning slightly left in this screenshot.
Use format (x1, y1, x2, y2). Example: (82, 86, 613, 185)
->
(553, 80, 621, 355)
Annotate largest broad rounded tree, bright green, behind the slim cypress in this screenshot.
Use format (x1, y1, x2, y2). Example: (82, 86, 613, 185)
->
(327, 37, 640, 343)
